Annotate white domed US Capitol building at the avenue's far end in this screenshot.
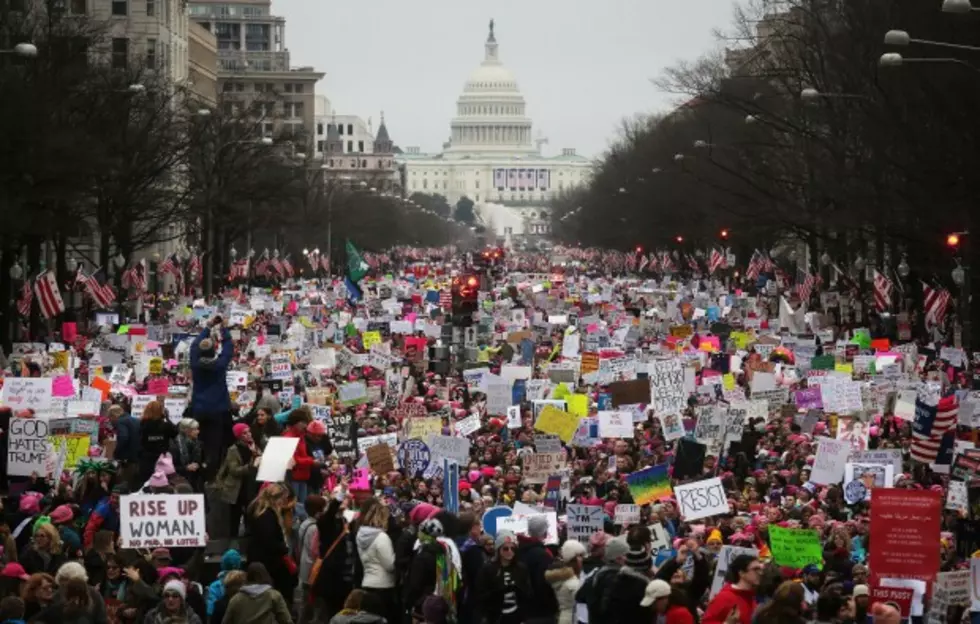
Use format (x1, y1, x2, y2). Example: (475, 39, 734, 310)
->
(396, 20, 592, 244)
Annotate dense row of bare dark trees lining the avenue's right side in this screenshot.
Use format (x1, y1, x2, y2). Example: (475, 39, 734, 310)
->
(552, 0, 980, 294)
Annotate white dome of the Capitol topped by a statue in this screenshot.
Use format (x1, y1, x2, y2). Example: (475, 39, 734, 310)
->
(445, 21, 537, 158)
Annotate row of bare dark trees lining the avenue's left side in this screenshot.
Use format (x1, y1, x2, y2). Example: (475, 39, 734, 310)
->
(0, 0, 468, 343)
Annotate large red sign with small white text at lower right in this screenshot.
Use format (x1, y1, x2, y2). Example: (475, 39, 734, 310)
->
(868, 488, 942, 584)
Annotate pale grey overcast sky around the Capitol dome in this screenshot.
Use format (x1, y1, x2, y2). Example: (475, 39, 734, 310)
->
(272, 0, 732, 156)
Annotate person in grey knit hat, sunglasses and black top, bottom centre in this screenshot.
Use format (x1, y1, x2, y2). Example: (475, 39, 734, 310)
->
(476, 531, 534, 624)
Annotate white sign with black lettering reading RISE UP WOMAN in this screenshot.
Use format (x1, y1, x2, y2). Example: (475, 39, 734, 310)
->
(119, 494, 207, 548)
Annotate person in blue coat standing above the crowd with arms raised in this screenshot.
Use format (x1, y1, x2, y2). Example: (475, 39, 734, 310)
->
(190, 316, 234, 482)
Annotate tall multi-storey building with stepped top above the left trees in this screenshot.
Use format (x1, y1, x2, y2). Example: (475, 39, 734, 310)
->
(188, 0, 324, 143)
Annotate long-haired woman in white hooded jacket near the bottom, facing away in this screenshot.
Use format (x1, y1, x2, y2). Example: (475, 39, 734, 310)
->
(355, 505, 398, 622)
